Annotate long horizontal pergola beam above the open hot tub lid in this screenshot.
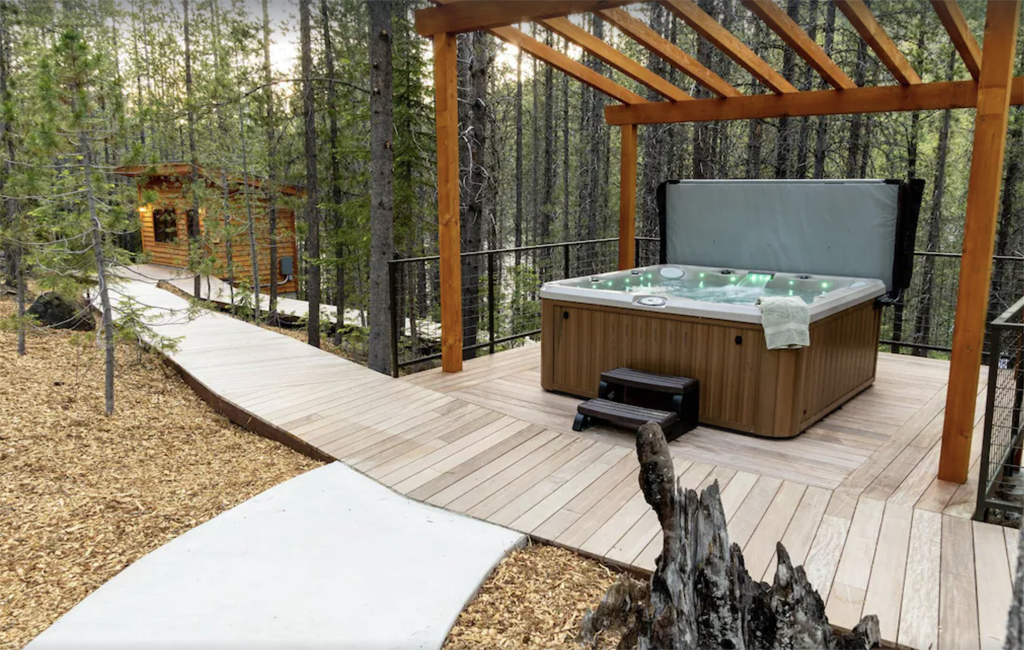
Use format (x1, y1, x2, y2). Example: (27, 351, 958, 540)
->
(604, 77, 1024, 126)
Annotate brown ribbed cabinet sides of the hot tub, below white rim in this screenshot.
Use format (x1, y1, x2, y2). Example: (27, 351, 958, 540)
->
(541, 298, 881, 438)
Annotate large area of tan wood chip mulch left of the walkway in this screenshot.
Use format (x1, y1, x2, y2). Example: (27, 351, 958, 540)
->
(0, 298, 321, 650)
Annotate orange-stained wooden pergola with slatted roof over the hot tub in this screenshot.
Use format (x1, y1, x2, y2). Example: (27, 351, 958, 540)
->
(416, 0, 1024, 483)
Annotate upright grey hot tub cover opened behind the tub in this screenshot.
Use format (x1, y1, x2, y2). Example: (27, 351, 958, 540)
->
(657, 179, 924, 300)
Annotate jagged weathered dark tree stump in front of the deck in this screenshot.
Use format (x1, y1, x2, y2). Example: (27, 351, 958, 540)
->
(580, 423, 881, 650)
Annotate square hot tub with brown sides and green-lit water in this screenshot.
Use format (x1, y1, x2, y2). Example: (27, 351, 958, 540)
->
(541, 264, 886, 438)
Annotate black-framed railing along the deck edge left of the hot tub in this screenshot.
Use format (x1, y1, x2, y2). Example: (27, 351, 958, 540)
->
(388, 237, 658, 377)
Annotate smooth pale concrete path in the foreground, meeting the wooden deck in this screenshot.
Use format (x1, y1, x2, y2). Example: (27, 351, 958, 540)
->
(28, 463, 525, 650)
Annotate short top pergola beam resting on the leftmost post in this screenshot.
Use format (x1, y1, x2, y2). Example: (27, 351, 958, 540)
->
(416, 0, 637, 36)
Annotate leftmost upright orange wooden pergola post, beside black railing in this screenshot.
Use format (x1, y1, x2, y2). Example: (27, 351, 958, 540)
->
(434, 34, 462, 373)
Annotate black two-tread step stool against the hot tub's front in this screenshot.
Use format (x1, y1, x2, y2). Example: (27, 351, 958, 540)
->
(572, 367, 700, 441)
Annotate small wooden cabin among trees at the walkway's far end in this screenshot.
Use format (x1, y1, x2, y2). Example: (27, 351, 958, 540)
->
(115, 163, 304, 294)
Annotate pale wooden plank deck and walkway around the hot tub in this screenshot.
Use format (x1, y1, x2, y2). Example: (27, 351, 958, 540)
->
(119, 274, 1017, 650)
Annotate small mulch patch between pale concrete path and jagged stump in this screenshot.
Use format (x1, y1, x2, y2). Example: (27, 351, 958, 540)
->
(443, 545, 617, 650)
